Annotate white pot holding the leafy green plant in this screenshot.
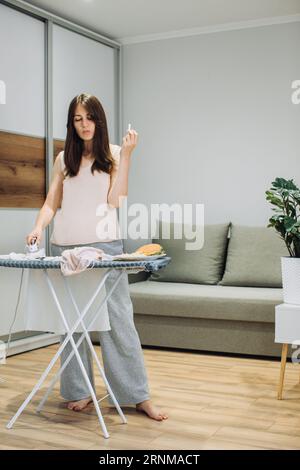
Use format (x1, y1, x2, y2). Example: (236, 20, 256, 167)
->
(281, 256, 300, 305)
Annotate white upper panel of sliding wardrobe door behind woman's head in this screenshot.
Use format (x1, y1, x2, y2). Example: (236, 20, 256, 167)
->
(53, 25, 118, 156)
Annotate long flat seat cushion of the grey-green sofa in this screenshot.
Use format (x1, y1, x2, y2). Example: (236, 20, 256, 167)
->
(129, 280, 282, 323)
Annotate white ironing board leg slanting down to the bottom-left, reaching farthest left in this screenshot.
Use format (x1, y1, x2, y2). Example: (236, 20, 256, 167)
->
(6, 269, 109, 436)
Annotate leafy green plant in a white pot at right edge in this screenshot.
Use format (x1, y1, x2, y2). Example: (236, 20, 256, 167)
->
(266, 178, 300, 305)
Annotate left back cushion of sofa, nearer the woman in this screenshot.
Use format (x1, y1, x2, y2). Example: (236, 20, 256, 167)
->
(149, 221, 229, 284)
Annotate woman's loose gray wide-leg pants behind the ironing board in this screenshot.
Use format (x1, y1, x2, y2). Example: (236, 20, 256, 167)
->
(51, 240, 150, 405)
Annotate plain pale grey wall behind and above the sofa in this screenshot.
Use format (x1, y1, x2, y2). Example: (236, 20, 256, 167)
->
(123, 23, 300, 250)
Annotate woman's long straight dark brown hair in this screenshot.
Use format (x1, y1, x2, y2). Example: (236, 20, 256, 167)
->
(64, 93, 114, 177)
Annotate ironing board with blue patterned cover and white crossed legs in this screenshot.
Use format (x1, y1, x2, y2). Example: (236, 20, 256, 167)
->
(0, 256, 171, 438)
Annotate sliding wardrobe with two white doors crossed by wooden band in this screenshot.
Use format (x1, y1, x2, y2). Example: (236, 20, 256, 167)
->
(0, 4, 120, 352)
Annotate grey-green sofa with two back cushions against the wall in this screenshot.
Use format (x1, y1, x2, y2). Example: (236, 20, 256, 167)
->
(129, 222, 288, 356)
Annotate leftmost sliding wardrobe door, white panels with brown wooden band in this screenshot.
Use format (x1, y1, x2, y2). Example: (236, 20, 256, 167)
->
(0, 4, 45, 340)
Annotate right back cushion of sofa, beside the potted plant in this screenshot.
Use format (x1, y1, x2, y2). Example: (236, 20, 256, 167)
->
(219, 225, 289, 287)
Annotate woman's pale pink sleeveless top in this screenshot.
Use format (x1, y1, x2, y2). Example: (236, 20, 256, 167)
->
(50, 144, 121, 245)
